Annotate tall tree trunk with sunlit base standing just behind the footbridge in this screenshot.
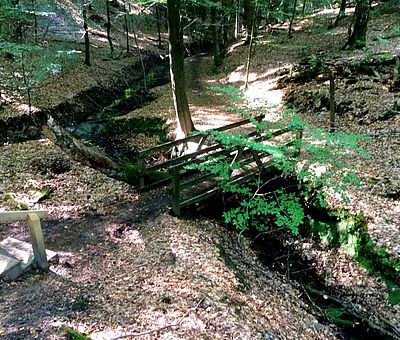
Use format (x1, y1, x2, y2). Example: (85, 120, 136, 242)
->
(167, 0, 195, 138)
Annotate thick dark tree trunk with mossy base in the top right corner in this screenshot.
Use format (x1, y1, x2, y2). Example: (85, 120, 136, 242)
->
(345, 0, 370, 49)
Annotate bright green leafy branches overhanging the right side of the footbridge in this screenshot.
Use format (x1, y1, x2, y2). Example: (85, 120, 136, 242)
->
(195, 88, 366, 238)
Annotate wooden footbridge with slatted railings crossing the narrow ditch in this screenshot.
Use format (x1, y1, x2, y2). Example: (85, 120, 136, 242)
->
(137, 115, 302, 216)
